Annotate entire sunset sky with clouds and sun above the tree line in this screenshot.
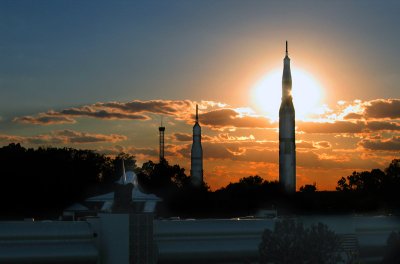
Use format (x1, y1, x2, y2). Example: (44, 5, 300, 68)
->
(0, 0, 400, 190)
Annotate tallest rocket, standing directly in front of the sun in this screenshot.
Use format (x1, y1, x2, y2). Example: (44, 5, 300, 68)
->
(279, 41, 296, 193)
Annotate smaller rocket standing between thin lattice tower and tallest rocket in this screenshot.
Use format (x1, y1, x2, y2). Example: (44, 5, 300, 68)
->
(190, 105, 203, 187)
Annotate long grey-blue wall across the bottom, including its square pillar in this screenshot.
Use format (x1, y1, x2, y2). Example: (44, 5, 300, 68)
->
(0, 214, 400, 264)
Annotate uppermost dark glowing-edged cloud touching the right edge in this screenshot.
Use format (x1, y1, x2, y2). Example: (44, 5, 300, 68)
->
(364, 99, 400, 119)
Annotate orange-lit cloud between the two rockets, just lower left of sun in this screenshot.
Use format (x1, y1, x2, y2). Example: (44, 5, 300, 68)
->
(200, 108, 275, 128)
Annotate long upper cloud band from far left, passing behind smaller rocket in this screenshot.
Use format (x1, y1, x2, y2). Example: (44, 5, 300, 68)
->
(13, 100, 277, 133)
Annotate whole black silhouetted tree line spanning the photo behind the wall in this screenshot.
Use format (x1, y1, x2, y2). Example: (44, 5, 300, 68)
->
(0, 143, 400, 218)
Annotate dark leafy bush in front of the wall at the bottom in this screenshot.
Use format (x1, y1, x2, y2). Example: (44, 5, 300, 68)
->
(259, 219, 340, 264)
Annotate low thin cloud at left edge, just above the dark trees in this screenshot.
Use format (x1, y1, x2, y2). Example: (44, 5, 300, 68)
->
(0, 130, 127, 144)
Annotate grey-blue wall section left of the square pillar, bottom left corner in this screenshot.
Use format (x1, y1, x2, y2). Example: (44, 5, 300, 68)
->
(0, 221, 98, 264)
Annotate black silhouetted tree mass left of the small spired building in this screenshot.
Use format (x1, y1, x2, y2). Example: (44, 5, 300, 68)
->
(0, 143, 136, 217)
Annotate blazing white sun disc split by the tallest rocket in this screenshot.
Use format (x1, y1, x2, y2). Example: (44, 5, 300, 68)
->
(251, 67, 323, 120)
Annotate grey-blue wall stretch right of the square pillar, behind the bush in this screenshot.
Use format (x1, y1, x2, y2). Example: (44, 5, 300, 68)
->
(154, 216, 400, 263)
